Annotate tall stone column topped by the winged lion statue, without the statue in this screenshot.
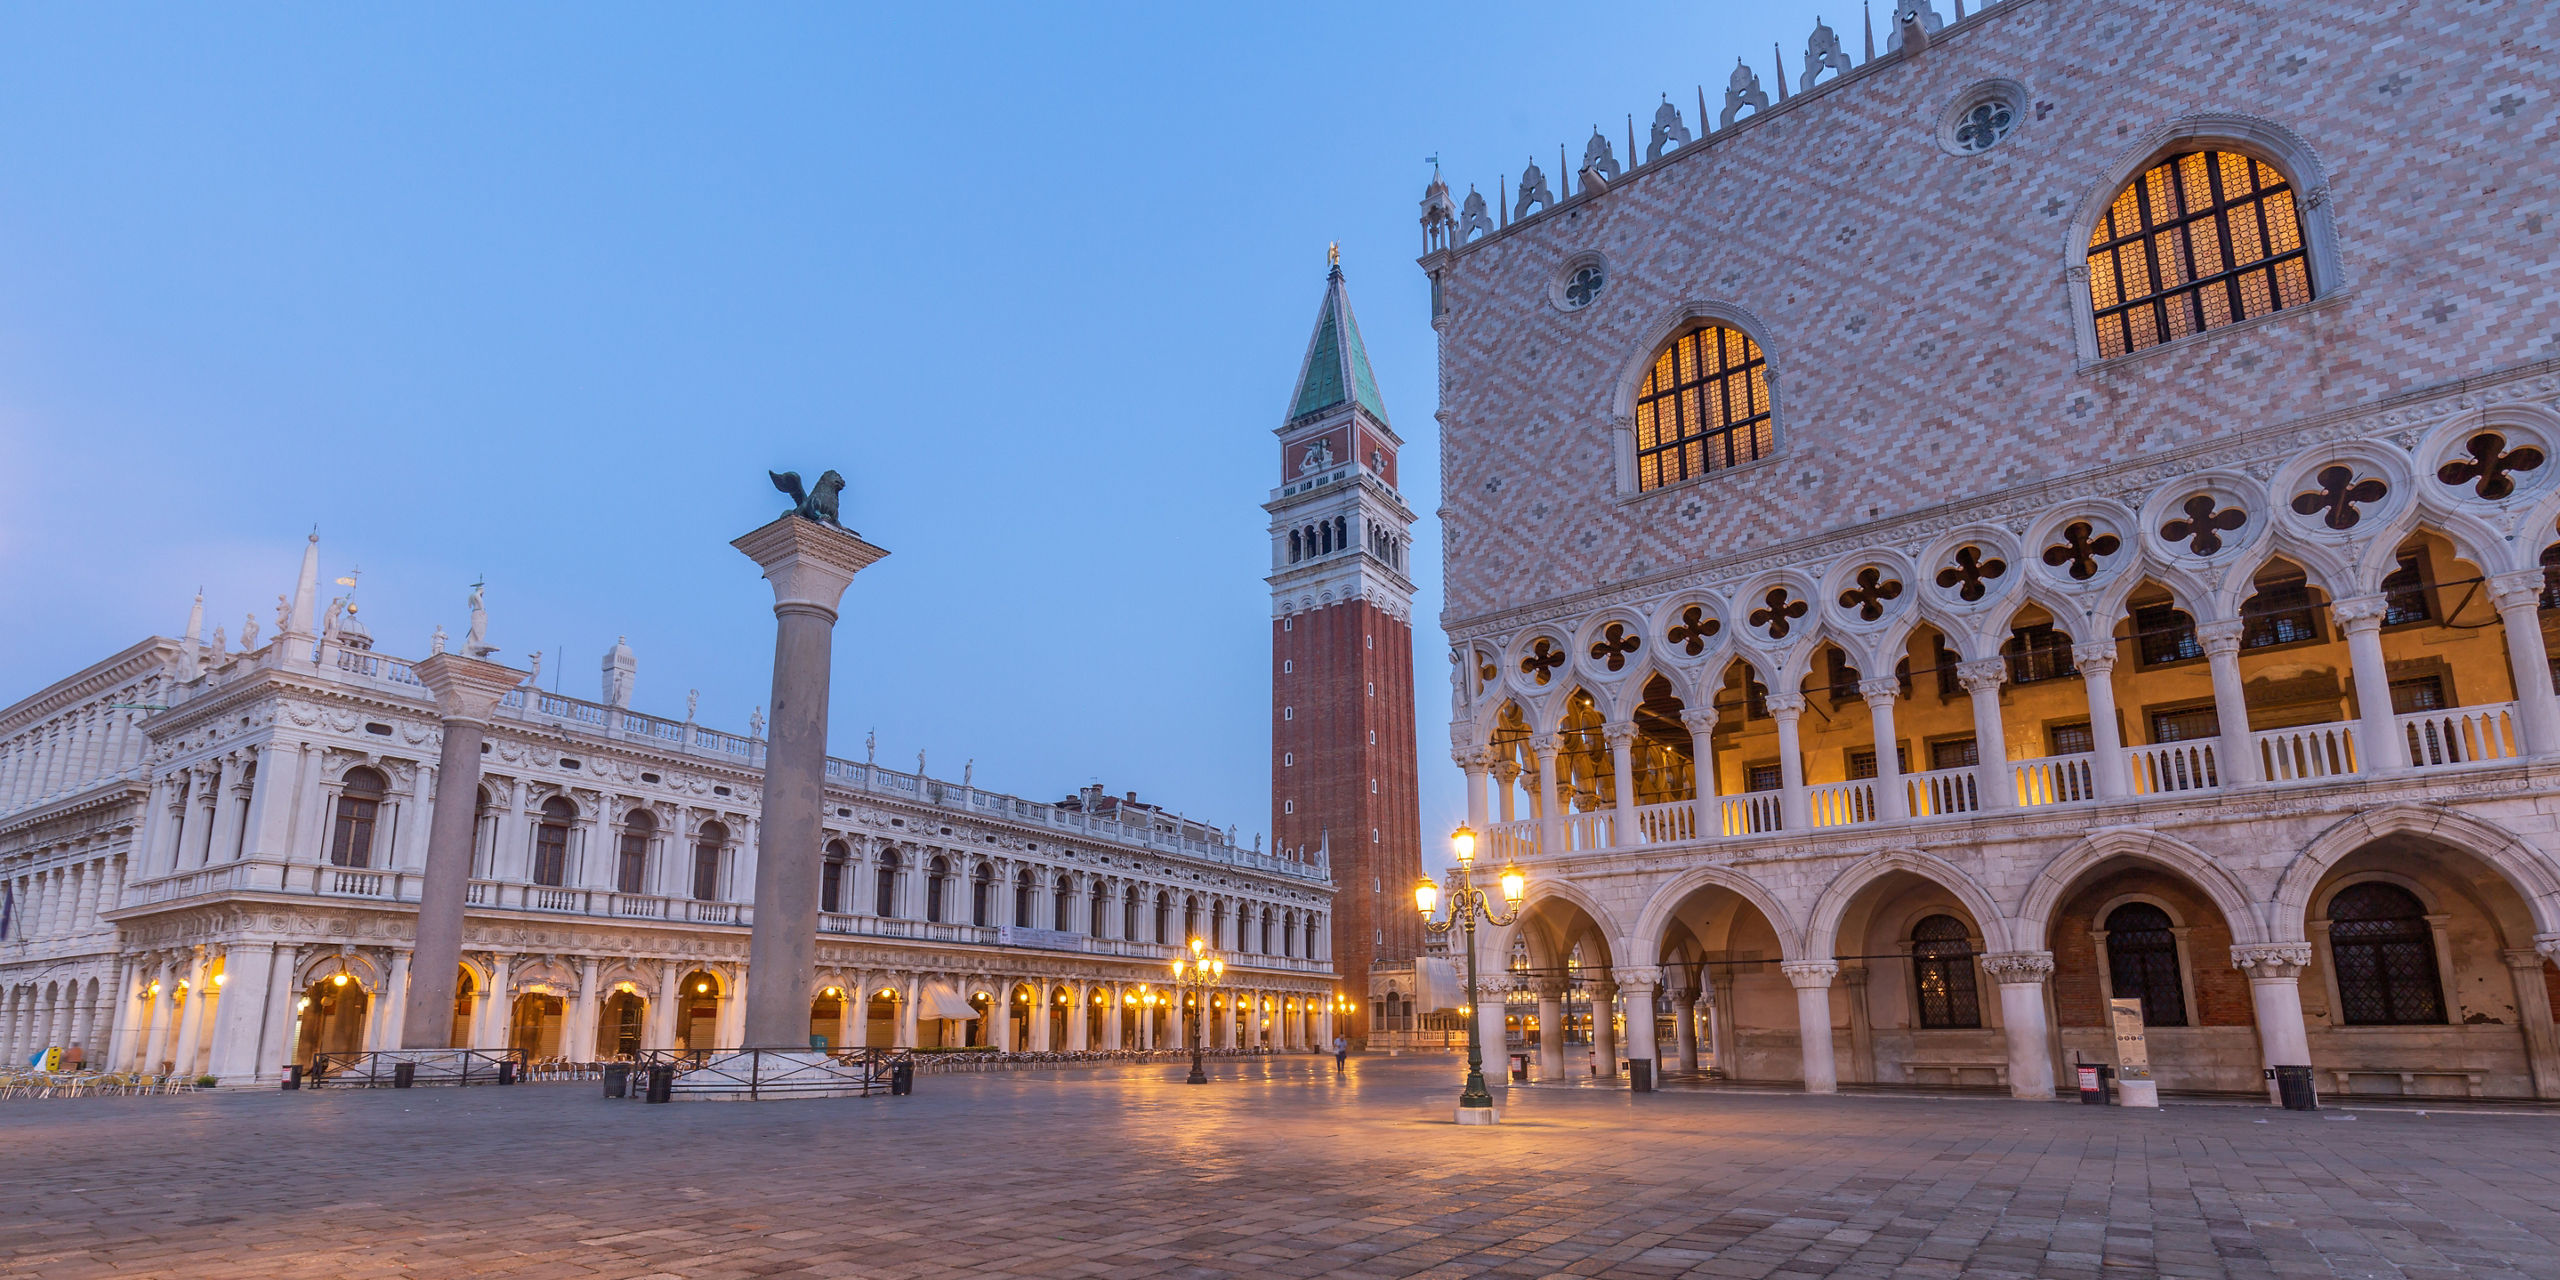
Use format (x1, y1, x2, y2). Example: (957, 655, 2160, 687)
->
(730, 515, 888, 1050)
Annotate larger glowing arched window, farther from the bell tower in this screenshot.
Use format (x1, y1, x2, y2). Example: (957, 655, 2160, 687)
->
(2089, 151, 2312, 358)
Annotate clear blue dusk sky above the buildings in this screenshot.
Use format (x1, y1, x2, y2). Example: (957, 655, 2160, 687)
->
(0, 0, 1843, 840)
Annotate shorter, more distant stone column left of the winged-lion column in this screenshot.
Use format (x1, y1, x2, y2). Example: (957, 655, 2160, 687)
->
(381, 653, 525, 1050)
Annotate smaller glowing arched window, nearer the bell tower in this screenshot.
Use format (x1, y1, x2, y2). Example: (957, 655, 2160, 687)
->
(1636, 325, 1777, 489)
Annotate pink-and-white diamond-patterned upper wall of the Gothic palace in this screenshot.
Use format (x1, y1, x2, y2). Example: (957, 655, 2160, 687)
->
(1439, 0, 2560, 635)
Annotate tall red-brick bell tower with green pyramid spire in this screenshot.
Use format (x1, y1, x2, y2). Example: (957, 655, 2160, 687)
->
(1262, 264, 1423, 1039)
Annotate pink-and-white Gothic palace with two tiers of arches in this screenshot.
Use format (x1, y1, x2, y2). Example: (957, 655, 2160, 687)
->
(1421, 0, 2560, 1098)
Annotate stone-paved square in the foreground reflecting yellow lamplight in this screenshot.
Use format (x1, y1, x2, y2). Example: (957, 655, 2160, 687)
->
(0, 1057, 2560, 1280)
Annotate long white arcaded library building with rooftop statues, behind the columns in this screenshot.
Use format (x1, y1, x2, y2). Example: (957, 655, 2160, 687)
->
(0, 538, 1334, 1083)
